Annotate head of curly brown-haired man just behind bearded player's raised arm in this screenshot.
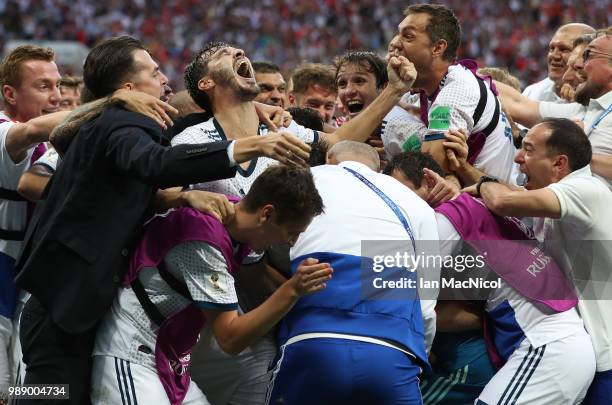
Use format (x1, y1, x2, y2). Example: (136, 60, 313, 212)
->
(289, 63, 338, 125)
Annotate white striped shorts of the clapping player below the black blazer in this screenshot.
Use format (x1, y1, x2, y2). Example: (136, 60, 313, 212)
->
(91, 356, 210, 405)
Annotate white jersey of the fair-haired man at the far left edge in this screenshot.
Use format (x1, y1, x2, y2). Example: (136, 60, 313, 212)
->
(0, 113, 34, 259)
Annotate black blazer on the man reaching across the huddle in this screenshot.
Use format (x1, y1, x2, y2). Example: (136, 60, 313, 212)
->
(16, 107, 236, 333)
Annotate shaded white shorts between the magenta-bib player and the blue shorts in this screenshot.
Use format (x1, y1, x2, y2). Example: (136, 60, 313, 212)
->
(189, 325, 276, 405)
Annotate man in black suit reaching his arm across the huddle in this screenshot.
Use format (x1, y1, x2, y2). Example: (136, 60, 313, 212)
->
(16, 37, 307, 405)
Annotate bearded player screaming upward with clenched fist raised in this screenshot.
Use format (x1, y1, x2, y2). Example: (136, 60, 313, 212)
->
(172, 42, 414, 404)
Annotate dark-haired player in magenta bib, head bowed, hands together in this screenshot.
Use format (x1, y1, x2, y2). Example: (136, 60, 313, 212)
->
(91, 165, 332, 404)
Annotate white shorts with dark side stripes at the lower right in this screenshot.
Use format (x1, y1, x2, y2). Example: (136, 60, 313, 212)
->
(475, 330, 595, 405)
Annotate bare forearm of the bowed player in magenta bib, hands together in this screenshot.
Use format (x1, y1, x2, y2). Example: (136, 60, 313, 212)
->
(215, 283, 298, 354)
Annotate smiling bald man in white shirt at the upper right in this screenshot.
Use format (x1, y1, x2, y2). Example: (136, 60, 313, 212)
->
(523, 23, 595, 103)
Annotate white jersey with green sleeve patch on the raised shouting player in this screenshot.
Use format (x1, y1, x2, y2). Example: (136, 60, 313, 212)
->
(400, 65, 518, 183)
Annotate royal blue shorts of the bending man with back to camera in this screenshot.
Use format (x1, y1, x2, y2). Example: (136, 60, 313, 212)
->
(267, 338, 421, 405)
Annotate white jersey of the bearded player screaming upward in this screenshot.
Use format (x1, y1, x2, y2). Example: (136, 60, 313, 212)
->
(172, 117, 319, 197)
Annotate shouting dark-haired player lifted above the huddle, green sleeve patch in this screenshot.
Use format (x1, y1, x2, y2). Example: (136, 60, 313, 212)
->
(387, 4, 517, 184)
